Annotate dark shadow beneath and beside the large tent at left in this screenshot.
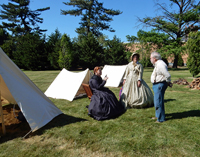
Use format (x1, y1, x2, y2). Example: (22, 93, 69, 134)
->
(0, 114, 86, 144)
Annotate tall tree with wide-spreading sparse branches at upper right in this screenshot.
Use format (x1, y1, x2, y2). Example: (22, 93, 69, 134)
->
(138, 0, 200, 68)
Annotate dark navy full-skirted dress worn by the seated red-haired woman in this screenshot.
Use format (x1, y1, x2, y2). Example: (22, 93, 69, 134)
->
(88, 75, 125, 120)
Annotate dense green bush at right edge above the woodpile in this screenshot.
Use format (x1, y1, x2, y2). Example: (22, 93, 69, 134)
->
(186, 32, 200, 77)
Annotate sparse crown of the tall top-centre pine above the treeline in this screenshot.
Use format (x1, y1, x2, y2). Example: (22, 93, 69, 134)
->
(61, 0, 122, 36)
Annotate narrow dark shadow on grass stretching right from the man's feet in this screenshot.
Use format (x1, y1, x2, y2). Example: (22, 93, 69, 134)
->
(165, 110, 200, 120)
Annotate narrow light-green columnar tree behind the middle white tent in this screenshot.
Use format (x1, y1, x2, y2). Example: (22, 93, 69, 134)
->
(58, 34, 73, 69)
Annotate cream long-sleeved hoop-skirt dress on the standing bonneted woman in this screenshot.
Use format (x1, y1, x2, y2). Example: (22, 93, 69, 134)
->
(120, 62, 154, 108)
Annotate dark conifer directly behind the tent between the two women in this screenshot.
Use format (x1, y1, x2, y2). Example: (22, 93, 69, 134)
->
(104, 36, 128, 65)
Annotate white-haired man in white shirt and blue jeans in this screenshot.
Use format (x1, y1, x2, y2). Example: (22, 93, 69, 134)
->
(150, 52, 172, 123)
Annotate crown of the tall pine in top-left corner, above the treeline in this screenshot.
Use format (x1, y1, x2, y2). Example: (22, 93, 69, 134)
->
(0, 0, 50, 35)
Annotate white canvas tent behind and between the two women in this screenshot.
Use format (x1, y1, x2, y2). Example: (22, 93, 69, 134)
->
(101, 65, 127, 87)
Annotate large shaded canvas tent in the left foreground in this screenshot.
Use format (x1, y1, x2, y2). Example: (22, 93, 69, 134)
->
(0, 48, 62, 131)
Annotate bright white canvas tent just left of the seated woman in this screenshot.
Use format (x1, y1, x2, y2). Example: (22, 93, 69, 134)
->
(45, 69, 91, 101)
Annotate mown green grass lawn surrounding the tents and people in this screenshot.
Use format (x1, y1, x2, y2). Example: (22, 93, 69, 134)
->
(0, 68, 200, 157)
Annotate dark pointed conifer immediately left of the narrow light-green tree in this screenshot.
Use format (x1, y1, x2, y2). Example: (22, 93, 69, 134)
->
(46, 29, 62, 69)
